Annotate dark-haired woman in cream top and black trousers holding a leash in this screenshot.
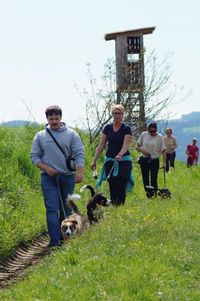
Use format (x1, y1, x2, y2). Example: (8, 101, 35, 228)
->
(136, 122, 166, 198)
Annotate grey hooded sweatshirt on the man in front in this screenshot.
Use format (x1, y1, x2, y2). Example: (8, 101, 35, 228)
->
(31, 123, 84, 174)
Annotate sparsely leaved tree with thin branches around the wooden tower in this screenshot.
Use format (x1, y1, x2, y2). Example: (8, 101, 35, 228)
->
(75, 51, 187, 144)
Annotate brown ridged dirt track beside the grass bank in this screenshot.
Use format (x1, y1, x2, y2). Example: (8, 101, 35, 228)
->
(0, 233, 50, 289)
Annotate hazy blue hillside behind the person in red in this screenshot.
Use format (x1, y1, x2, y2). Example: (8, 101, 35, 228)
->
(158, 112, 200, 161)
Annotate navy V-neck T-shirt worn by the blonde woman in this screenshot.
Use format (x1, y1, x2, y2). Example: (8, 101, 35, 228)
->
(103, 123, 132, 158)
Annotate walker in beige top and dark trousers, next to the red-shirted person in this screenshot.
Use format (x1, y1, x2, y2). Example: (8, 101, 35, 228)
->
(164, 128, 177, 172)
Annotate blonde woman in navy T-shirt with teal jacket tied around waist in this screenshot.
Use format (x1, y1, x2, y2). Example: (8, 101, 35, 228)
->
(91, 104, 132, 206)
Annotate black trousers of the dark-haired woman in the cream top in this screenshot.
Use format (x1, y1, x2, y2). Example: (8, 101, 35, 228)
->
(140, 159, 159, 192)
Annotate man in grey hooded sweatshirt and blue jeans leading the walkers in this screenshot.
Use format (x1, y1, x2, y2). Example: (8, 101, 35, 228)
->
(31, 105, 84, 247)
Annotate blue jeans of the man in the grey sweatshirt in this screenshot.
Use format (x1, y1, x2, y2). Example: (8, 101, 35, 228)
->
(41, 173, 75, 246)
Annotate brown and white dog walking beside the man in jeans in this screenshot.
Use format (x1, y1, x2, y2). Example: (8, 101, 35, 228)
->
(61, 194, 86, 240)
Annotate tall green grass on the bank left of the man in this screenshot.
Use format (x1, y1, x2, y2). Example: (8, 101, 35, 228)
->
(0, 127, 46, 259)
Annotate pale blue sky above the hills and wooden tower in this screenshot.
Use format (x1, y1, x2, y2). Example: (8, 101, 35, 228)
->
(0, 0, 200, 125)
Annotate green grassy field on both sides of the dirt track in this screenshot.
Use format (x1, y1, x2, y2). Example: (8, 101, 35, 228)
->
(0, 128, 200, 301)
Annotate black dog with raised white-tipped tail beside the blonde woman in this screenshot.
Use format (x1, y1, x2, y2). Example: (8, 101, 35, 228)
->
(80, 184, 111, 224)
